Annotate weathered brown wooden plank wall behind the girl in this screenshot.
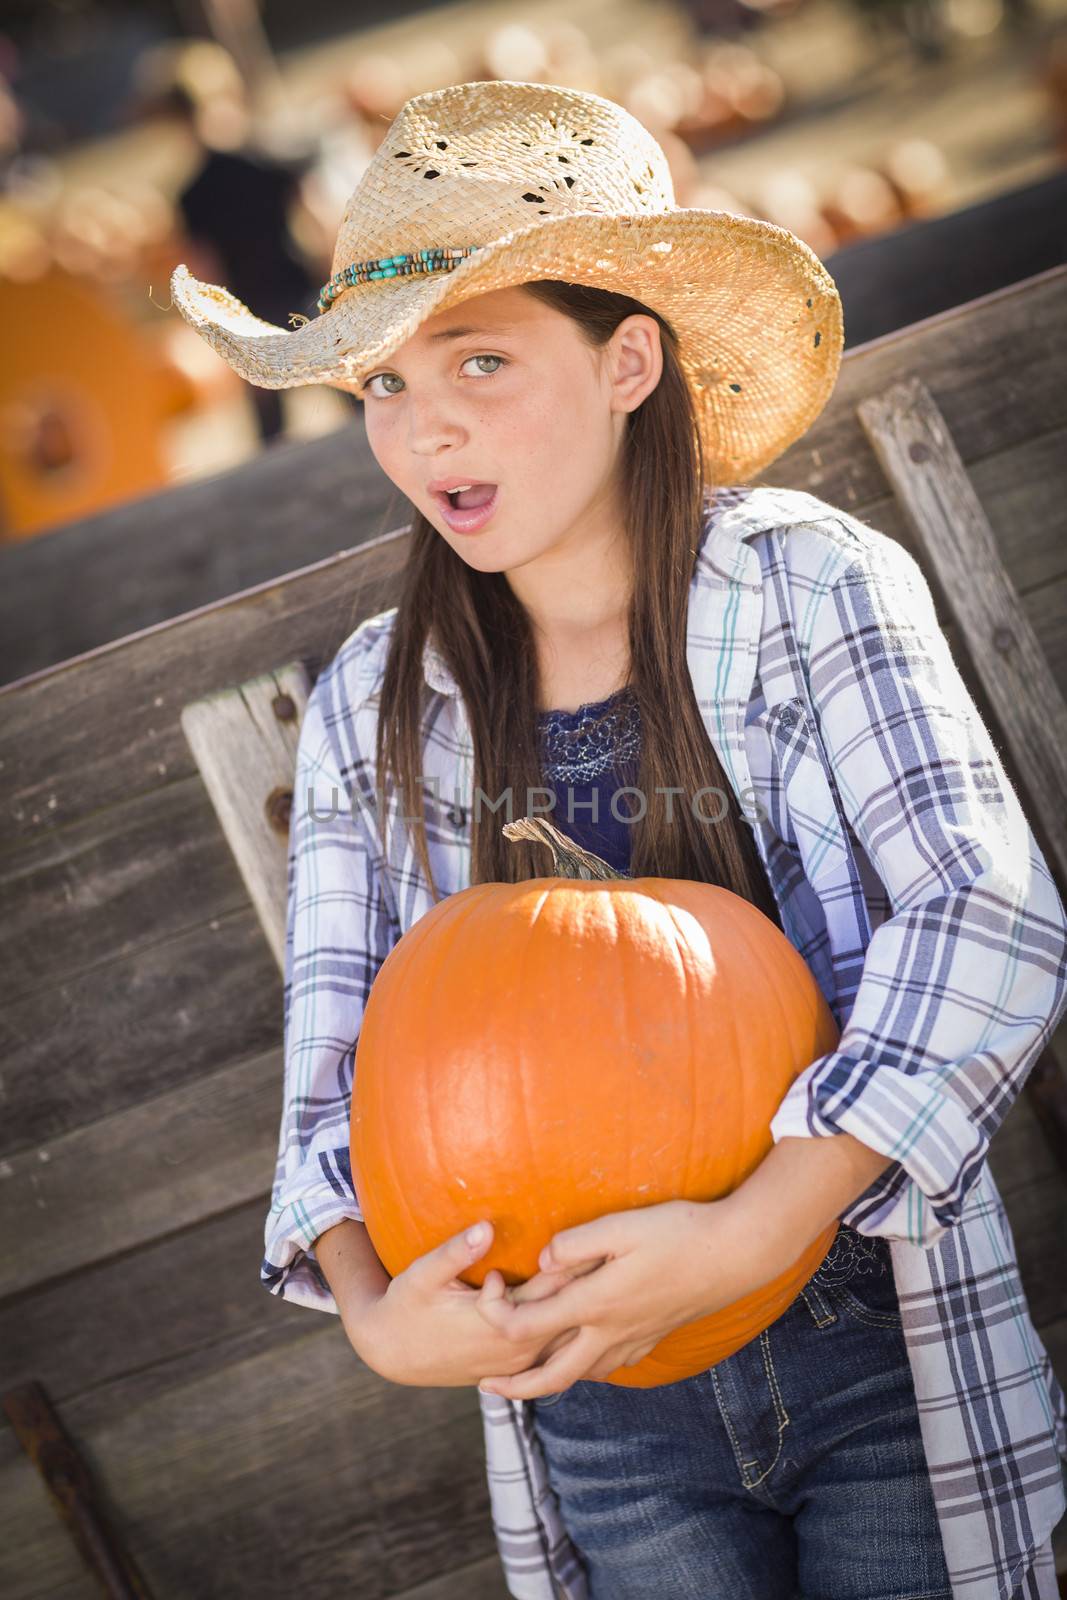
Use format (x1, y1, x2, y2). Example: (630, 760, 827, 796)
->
(0, 269, 1067, 1600)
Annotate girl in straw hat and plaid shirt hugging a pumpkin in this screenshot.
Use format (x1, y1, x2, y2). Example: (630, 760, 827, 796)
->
(173, 83, 1067, 1600)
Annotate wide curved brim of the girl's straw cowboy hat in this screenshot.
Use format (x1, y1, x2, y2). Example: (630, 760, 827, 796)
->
(171, 208, 845, 482)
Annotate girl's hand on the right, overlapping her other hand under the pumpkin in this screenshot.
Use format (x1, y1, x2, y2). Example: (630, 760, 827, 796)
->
(477, 1197, 784, 1400)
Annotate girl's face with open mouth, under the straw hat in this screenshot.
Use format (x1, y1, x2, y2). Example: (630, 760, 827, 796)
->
(360, 288, 662, 571)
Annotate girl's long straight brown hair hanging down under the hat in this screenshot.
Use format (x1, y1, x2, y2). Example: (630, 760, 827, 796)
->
(376, 278, 781, 926)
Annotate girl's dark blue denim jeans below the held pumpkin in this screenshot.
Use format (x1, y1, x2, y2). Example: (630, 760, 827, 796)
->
(533, 1227, 952, 1600)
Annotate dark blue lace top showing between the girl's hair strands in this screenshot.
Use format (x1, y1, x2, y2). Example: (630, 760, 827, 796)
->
(537, 685, 641, 872)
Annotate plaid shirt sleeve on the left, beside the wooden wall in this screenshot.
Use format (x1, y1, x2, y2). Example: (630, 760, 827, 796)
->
(261, 669, 395, 1312)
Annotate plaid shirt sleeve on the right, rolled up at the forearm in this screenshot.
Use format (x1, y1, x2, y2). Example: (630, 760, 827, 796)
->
(771, 539, 1067, 1245)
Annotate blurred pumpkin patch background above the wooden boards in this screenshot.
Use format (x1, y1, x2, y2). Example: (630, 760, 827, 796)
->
(0, 0, 1067, 553)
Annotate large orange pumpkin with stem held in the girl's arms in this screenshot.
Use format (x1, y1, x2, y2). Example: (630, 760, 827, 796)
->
(350, 818, 838, 1389)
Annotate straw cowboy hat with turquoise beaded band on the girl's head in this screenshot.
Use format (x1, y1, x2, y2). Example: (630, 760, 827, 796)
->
(171, 82, 845, 483)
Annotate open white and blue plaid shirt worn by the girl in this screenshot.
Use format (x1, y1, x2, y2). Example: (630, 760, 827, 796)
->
(262, 486, 1067, 1600)
